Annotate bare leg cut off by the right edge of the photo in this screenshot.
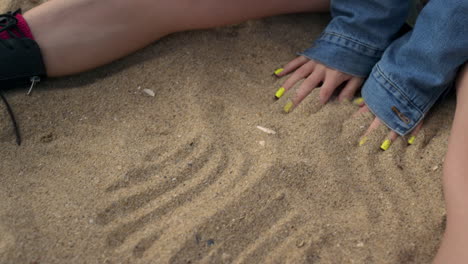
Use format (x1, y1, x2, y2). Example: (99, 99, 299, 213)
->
(435, 65, 468, 264)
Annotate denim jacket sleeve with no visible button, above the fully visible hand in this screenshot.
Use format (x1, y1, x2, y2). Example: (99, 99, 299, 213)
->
(301, 0, 410, 78)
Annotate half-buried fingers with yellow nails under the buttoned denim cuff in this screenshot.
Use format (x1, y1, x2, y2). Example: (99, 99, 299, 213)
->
(353, 98, 422, 151)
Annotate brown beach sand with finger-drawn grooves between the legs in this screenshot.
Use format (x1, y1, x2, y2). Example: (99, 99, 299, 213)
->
(0, 0, 454, 264)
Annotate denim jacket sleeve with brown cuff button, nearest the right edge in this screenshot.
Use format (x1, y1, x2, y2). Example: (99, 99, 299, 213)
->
(362, 0, 468, 135)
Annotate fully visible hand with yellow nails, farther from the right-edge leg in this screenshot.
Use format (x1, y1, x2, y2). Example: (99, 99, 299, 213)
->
(274, 56, 363, 113)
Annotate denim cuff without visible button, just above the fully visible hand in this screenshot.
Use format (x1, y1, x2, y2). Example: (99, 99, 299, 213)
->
(299, 32, 383, 78)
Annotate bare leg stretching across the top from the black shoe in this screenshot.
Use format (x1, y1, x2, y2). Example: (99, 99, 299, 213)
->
(25, 0, 329, 76)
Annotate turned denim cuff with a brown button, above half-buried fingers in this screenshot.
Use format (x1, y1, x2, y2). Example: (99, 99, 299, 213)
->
(362, 65, 425, 136)
